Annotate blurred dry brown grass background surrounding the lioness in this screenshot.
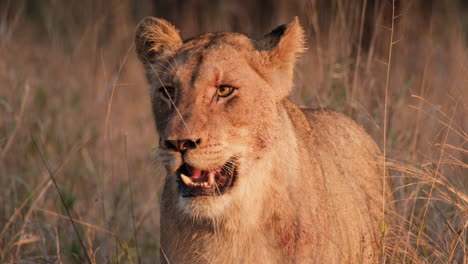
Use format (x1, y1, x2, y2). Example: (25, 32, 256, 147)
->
(0, 0, 468, 263)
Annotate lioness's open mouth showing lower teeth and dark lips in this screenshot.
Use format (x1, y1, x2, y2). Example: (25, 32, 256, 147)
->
(177, 160, 237, 197)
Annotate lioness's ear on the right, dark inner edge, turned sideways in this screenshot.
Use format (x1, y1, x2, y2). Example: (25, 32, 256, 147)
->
(256, 17, 306, 96)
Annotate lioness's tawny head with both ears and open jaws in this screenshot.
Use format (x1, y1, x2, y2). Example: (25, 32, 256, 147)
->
(136, 18, 302, 217)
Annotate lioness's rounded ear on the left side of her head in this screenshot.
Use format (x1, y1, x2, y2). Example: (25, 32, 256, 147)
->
(135, 17, 182, 64)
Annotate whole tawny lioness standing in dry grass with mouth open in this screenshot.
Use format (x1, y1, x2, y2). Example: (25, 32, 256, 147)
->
(135, 17, 383, 263)
